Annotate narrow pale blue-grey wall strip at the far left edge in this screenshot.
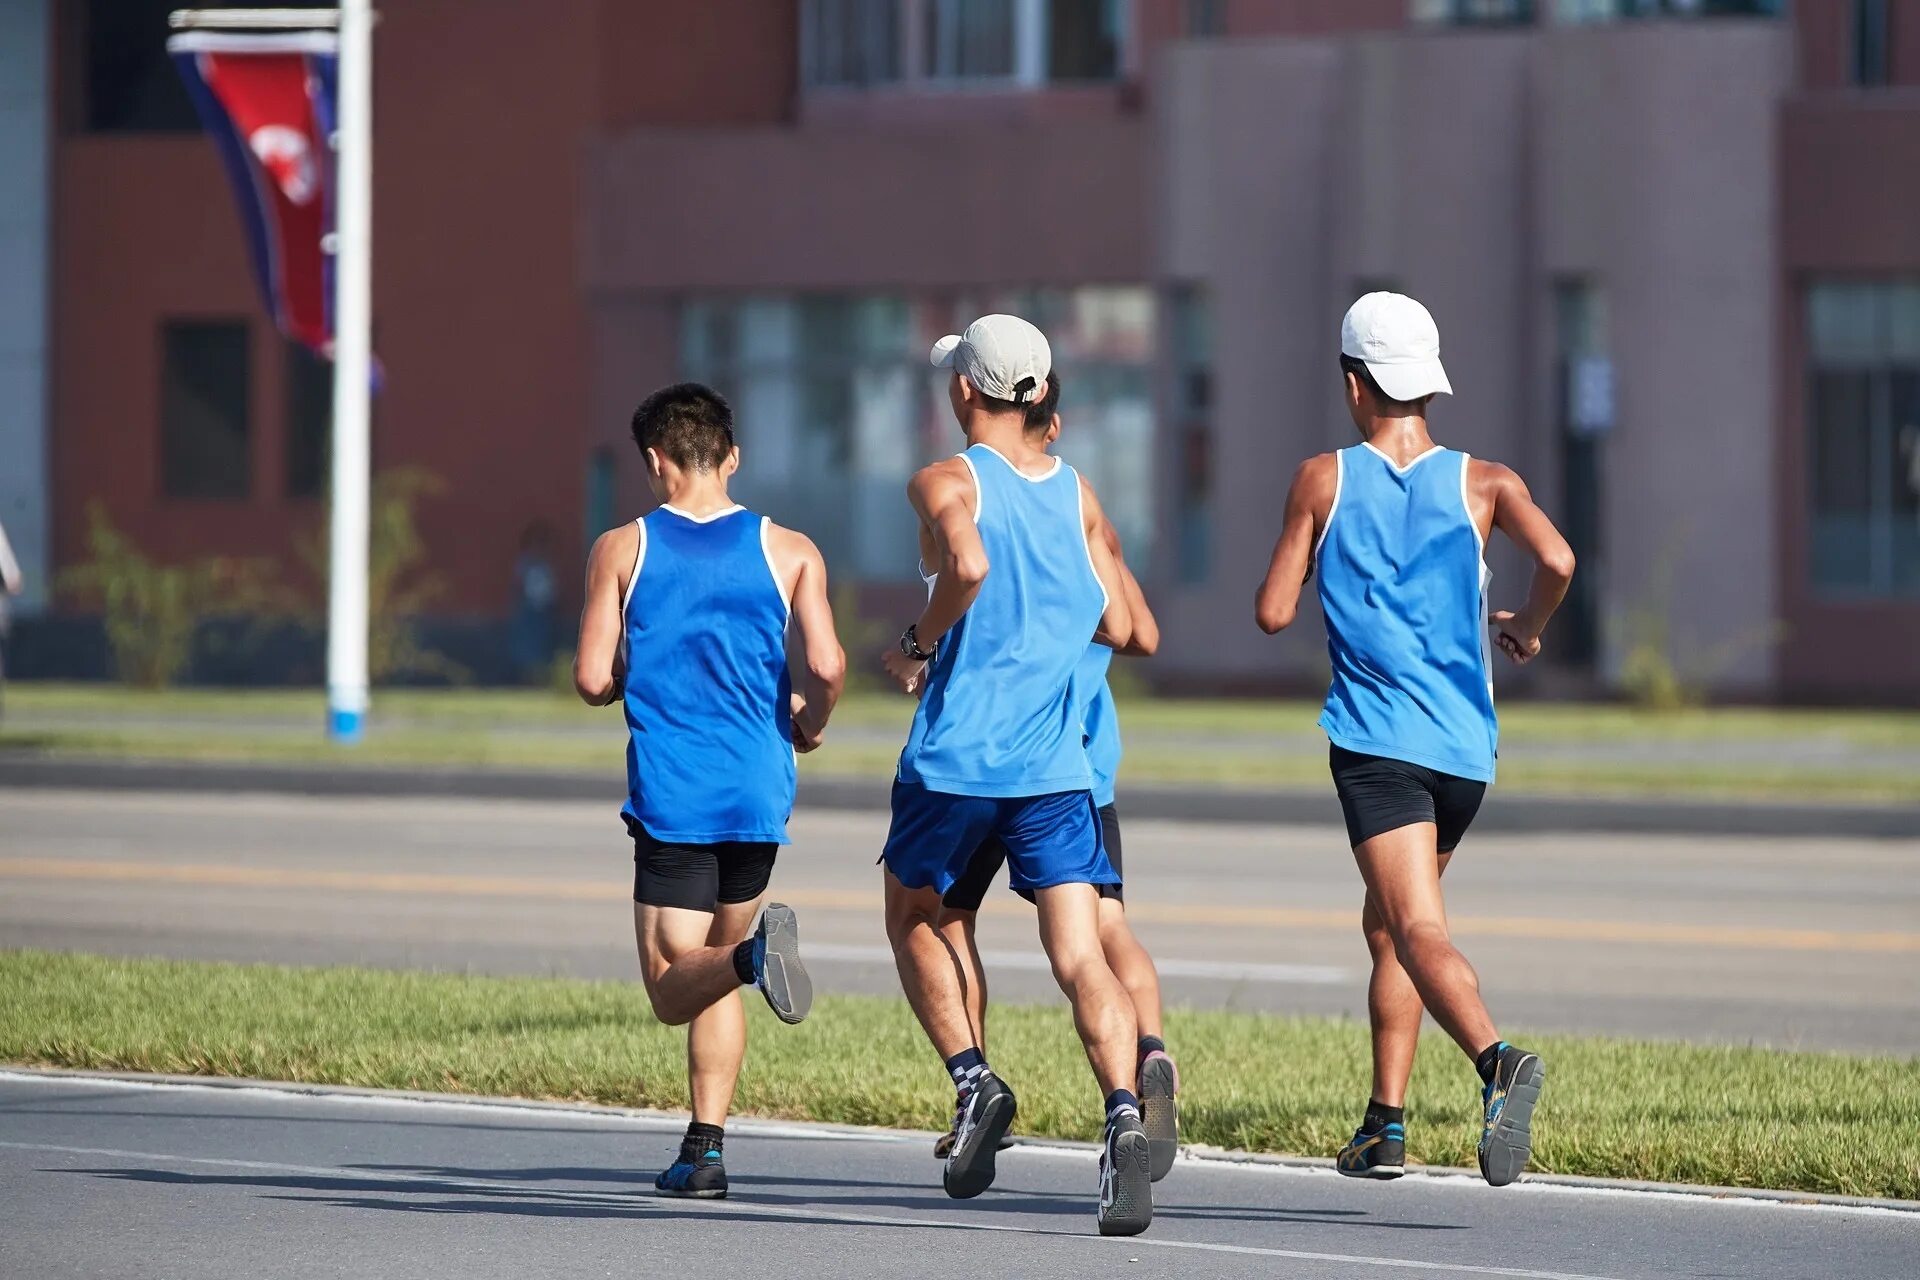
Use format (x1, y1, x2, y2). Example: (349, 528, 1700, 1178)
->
(0, 0, 54, 608)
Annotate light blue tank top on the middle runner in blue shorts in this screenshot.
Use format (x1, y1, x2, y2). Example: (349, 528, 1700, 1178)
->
(899, 445, 1106, 796)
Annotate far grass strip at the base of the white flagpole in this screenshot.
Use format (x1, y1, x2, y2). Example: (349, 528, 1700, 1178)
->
(0, 683, 1920, 802)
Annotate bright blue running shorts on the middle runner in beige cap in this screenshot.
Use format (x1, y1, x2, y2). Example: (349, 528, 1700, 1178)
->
(879, 781, 1119, 894)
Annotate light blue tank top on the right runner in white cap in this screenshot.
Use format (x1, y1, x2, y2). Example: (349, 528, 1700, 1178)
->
(1315, 445, 1500, 783)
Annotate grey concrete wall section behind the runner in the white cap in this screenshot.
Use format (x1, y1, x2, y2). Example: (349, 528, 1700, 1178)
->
(1156, 21, 1791, 687)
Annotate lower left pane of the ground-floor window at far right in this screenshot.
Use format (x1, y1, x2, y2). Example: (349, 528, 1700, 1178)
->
(1811, 372, 1874, 589)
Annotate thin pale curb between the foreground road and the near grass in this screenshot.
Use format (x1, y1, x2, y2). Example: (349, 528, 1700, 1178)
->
(0, 1063, 1920, 1217)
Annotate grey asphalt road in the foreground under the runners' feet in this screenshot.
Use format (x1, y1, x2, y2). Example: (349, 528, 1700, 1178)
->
(0, 1075, 1920, 1280)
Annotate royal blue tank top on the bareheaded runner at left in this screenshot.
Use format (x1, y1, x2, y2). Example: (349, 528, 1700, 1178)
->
(622, 507, 793, 844)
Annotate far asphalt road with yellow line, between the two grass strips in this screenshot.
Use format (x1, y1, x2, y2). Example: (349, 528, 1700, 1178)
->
(0, 789, 1920, 1054)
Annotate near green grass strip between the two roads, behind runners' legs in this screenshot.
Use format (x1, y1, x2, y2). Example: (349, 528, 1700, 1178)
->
(0, 952, 1920, 1199)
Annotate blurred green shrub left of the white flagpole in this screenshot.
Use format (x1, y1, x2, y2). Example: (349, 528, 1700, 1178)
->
(60, 503, 276, 689)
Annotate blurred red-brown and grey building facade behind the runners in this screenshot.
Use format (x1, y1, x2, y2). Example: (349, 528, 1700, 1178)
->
(0, 0, 1920, 704)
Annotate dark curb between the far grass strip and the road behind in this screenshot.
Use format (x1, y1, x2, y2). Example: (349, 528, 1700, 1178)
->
(0, 752, 1920, 839)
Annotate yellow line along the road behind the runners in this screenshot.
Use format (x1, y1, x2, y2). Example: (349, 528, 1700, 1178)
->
(0, 858, 1920, 954)
